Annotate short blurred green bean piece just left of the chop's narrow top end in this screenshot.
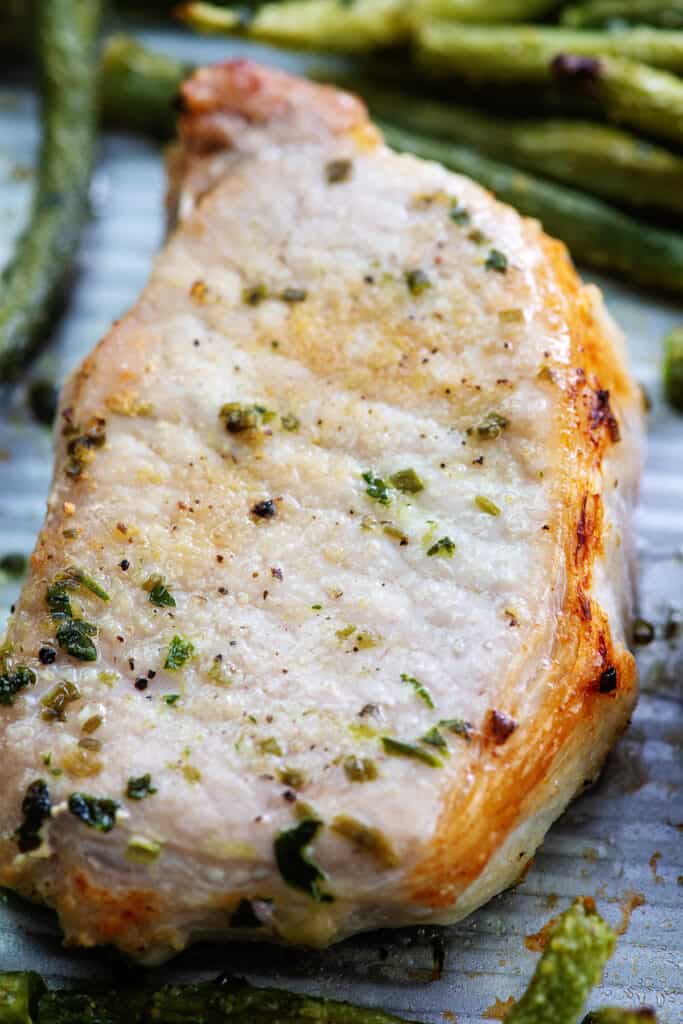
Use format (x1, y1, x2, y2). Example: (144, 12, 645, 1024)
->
(99, 36, 191, 138)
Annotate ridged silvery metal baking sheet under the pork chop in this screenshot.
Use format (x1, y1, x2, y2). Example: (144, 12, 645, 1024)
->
(0, 24, 683, 1024)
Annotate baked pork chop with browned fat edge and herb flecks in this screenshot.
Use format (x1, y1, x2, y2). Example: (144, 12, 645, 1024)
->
(0, 62, 642, 963)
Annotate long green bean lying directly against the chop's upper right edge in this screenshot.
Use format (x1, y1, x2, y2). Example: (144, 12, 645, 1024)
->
(382, 124, 683, 295)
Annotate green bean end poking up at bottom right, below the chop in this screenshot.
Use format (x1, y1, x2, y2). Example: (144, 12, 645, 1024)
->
(505, 900, 616, 1024)
